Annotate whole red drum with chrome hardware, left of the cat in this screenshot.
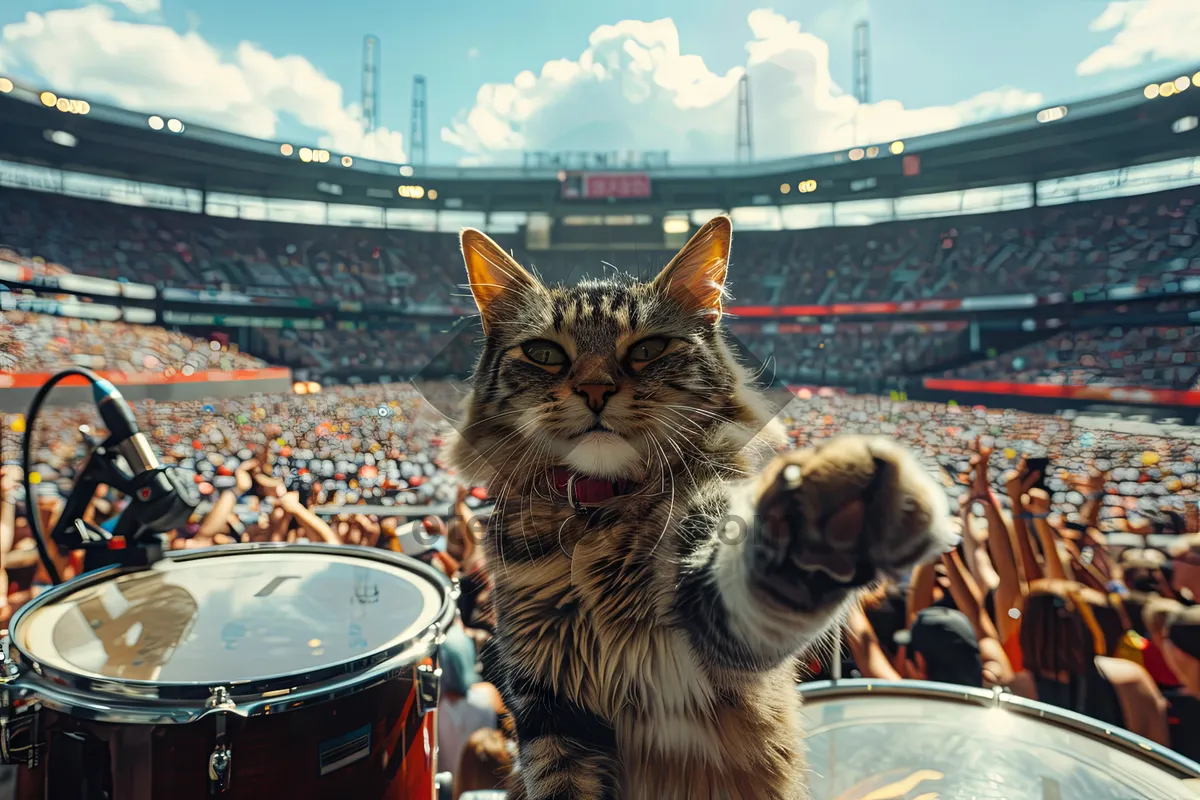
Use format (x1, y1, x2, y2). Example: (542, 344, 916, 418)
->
(0, 545, 457, 800)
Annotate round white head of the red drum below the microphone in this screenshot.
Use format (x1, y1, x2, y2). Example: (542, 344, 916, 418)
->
(12, 546, 448, 694)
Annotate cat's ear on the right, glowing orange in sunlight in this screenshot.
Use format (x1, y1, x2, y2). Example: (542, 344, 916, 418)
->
(654, 213, 733, 323)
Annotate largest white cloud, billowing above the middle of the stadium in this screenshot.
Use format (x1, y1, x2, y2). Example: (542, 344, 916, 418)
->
(442, 10, 1042, 163)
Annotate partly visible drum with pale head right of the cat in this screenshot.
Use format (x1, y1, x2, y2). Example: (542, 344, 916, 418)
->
(800, 680, 1200, 800)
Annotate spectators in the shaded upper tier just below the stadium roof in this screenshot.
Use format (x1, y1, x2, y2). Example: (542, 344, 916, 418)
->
(0, 188, 1200, 305)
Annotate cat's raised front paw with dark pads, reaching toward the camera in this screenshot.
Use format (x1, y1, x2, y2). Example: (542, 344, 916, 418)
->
(749, 437, 958, 612)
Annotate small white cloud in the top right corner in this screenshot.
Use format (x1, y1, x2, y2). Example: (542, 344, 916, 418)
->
(1075, 0, 1200, 76)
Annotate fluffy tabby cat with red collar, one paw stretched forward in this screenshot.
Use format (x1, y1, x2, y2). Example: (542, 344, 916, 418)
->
(451, 216, 955, 800)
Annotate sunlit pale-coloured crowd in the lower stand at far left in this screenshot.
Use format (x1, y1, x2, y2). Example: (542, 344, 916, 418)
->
(0, 311, 266, 375)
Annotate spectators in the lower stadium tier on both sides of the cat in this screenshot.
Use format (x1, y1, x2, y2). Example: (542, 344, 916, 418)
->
(9, 311, 1200, 390)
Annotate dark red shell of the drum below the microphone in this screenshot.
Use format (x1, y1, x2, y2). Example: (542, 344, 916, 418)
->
(17, 668, 437, 800)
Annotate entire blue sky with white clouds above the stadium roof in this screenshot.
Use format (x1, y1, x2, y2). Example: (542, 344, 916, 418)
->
(0, 0, 1200, 163)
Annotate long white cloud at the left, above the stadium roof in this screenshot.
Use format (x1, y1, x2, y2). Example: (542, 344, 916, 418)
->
(0, 0, 406, 162)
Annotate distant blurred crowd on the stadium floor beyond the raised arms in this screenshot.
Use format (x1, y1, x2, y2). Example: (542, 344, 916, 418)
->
(7, 381, 1200, 533)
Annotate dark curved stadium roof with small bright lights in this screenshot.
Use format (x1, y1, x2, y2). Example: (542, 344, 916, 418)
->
(0, 67, 1200, 213)
